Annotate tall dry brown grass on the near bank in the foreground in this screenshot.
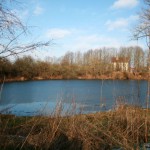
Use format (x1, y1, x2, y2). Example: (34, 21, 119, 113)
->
(0, 105, 150, 150)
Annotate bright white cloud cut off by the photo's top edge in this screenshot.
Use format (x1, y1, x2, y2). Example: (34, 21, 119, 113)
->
(112, 0, 138, 9)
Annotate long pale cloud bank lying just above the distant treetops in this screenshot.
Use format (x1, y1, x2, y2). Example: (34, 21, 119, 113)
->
(58, 34, 143, 55)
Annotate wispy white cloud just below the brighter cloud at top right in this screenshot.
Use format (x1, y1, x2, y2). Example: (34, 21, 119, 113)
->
(106, 15, 138, 31)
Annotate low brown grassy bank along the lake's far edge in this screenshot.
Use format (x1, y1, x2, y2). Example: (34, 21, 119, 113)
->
(0, 72, 149, 83)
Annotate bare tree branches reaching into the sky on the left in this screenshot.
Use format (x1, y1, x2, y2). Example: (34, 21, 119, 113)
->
(0, 0, 50, 59)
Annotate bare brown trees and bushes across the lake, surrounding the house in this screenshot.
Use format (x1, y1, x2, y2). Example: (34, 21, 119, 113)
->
(0, 46, 150, 81)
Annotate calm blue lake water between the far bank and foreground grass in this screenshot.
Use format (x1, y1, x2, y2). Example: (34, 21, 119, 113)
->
(0, 80, 147, 116)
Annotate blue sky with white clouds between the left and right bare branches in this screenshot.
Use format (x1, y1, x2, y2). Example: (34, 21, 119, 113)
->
(15, 0, 144, 58)
